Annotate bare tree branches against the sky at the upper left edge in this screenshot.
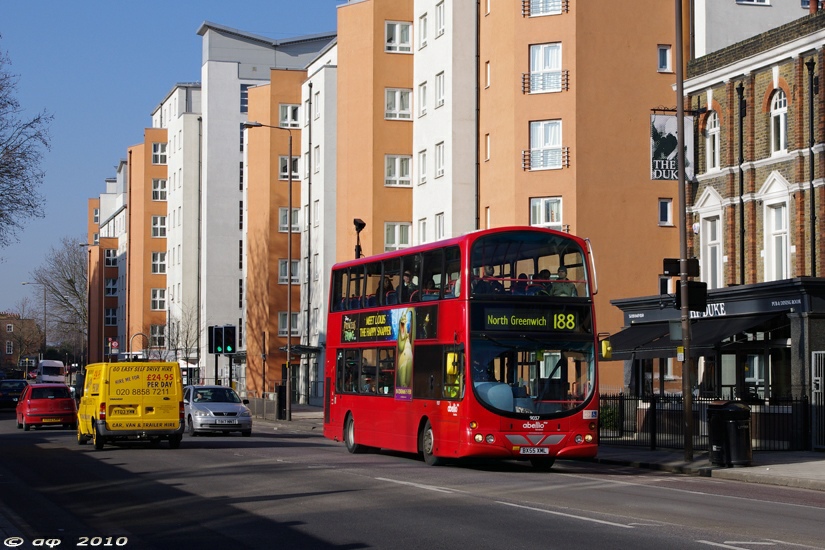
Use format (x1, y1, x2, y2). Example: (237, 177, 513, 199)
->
(0, 41, 54, 252)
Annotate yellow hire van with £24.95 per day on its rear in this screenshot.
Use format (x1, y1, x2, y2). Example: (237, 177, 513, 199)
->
(77, 362, 184, 449)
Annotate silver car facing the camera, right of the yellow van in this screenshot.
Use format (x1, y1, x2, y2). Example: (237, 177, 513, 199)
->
(183, 386, 252, 437)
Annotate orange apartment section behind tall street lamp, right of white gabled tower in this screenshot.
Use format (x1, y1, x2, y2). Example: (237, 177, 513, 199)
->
(243, 69, 307, 394)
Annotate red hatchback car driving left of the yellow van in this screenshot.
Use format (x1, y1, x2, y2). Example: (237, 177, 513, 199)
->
(17, 384, 77, 431)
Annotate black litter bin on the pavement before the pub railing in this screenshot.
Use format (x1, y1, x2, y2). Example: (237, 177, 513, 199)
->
(707, 401, 753, 466)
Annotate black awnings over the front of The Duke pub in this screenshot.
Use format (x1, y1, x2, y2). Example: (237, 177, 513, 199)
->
(610, 313, 784, 360)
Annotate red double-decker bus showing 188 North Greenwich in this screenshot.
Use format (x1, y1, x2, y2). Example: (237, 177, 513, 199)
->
(324, 227, 599, 469)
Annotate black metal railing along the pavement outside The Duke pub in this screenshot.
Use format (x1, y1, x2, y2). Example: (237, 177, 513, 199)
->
(599, 393, 811, 451)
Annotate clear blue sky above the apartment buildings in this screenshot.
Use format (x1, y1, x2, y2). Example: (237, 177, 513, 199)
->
(0, 0, 346, 311)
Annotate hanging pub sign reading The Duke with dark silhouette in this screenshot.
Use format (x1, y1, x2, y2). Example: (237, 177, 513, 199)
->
(650, 115, 694, 181)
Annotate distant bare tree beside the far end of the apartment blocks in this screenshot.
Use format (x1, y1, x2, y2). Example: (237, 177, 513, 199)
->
(31, 237, 89, 349)
